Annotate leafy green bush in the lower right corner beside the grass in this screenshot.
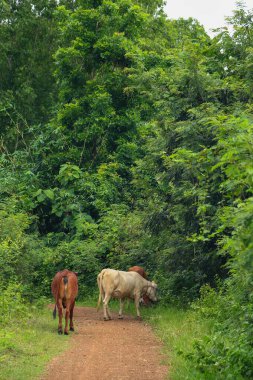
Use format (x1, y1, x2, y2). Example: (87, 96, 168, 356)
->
(192, 279, 253, 379)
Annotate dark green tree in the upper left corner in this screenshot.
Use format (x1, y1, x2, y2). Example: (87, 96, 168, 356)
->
(0, 0, 57, 152)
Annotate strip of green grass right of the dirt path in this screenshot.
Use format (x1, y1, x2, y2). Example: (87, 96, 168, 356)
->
(141, 306, 215, 380)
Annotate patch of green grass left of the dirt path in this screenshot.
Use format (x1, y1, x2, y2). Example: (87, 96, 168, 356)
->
(0, 308, 69, 380)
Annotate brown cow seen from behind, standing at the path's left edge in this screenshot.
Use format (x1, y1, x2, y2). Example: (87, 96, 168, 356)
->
(51, 269, 78, 335)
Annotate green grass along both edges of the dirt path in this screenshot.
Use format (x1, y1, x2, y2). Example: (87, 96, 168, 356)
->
(0, 298, 212, 380)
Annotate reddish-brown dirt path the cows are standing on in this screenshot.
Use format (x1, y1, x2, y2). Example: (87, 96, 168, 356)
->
(42, 307, 168, 380)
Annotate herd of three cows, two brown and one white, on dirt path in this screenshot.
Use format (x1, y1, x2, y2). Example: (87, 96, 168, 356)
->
(51, 266, 157, 335)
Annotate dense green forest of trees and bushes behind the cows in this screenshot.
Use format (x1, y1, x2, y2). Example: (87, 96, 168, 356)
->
(0, 0, 253, 379)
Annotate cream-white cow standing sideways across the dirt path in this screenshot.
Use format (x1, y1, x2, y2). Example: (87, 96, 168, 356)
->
(97, 269, 157, 321)
